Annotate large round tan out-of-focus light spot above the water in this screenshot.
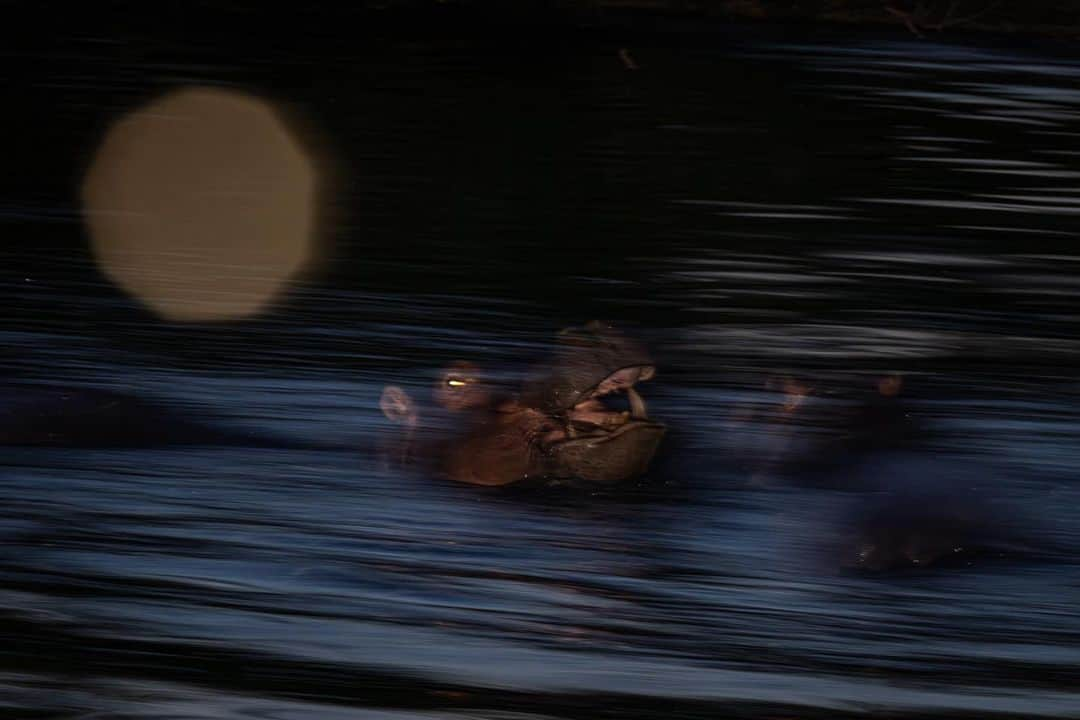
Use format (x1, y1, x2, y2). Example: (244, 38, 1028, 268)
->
(82, 87, 318, 322)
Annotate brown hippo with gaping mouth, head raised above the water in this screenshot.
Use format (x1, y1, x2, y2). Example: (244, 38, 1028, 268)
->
(382, 323, 665, 486)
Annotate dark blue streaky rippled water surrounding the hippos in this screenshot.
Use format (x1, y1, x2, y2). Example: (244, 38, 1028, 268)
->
(6, 18, 1080, 718)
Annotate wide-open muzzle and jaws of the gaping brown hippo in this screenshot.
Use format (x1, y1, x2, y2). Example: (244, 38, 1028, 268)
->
(522, 322, 665, 484)
